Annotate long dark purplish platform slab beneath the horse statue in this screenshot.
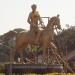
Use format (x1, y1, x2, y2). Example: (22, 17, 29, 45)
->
(5, 64, 63, 75)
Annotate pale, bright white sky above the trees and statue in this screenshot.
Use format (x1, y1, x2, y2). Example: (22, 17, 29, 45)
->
(0, 0, 75, 35)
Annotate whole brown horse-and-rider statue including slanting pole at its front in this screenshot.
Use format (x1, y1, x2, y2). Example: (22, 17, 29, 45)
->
(3, 4, 73, 72)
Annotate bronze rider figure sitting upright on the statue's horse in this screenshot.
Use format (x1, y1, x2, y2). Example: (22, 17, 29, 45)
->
(27, 4, 43, 43)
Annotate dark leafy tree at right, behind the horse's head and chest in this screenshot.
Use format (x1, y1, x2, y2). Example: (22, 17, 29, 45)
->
(55, 27, 75, 53)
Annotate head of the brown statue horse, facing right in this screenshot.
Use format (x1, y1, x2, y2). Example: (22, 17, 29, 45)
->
(48, 15, 61, 29)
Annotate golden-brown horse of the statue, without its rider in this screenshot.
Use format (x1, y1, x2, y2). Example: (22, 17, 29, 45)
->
(13, 17, 61, 62)
